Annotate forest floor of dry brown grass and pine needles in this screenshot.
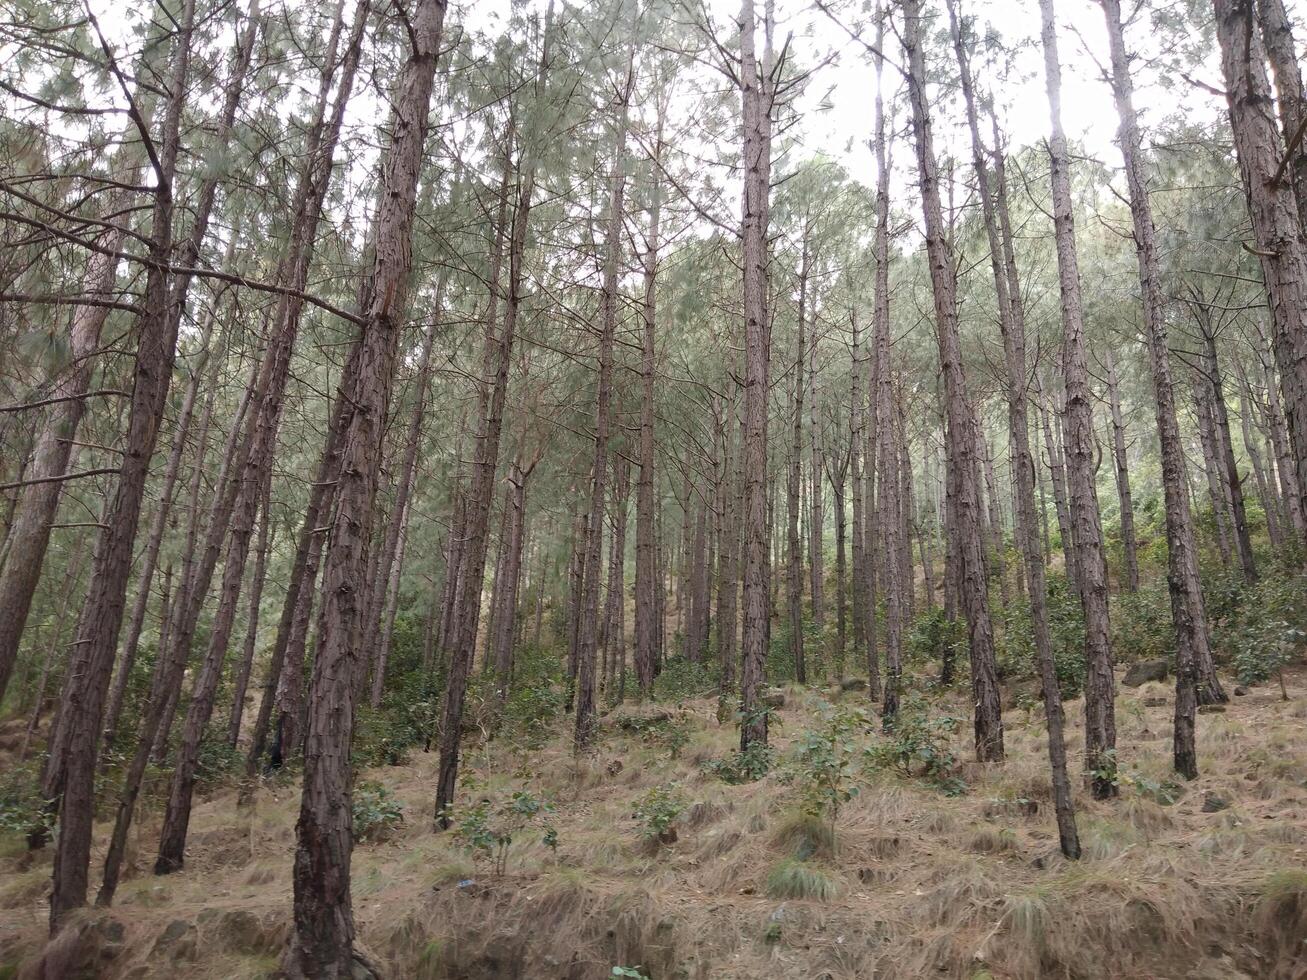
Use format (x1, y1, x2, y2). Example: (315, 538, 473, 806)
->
(0, 668, 1307, 980)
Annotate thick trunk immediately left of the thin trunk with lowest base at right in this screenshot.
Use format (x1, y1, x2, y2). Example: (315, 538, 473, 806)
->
(903, 0, 1004, 762)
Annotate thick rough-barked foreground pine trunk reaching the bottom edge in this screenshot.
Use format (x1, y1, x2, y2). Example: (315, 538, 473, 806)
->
(284, 0, 444, 980)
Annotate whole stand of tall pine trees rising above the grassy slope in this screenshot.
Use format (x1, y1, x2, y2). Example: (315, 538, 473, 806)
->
(0, 0, 1307, 977)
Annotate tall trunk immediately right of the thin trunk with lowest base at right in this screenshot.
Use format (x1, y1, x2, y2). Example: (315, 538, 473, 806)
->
(1039, 0, 1116, 798)
